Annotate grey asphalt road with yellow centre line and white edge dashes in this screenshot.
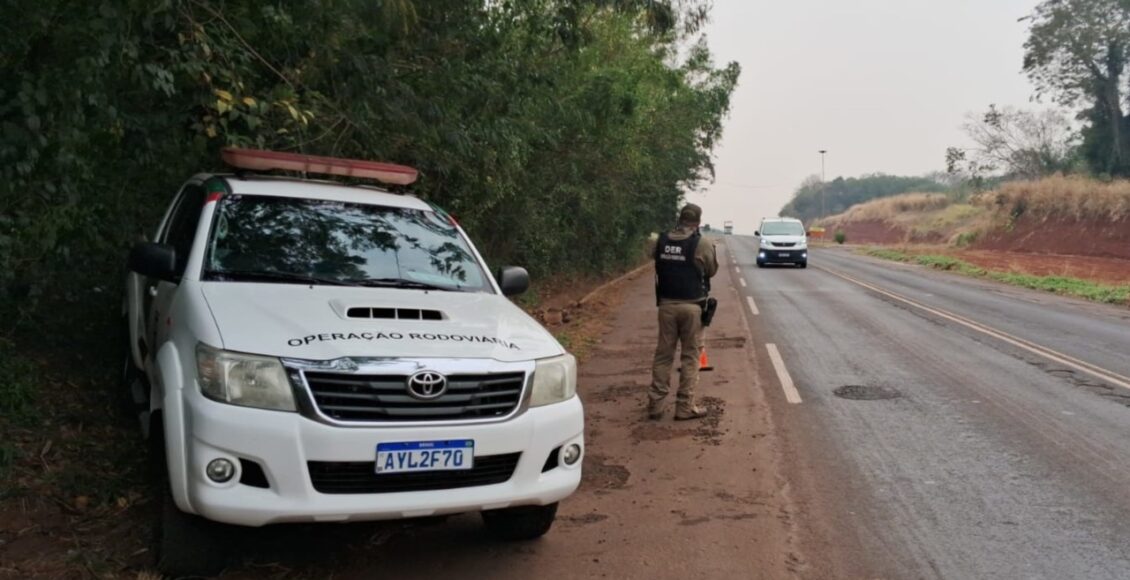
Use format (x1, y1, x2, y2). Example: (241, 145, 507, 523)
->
(725, 236, 1130, 579)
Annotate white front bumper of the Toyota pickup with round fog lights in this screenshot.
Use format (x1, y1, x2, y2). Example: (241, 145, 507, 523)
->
(173, 396, 584, 526)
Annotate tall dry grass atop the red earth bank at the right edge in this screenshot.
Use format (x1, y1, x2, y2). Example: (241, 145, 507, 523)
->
(973, 175, 1130, 222)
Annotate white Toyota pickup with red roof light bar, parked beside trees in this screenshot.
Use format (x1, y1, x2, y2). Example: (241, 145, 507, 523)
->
(124, 149, 584, 575)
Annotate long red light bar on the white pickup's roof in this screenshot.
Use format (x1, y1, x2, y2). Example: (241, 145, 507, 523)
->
(220, 147, 418, 185)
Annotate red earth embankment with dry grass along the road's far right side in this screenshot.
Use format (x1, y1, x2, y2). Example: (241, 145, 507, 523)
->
(817, 176, 1130, 293)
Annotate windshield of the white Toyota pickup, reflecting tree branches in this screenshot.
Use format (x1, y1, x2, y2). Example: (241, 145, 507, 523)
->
(205, 194, 489, 292)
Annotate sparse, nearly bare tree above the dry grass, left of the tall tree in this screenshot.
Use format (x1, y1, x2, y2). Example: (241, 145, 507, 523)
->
(947, 105, 1075, 179)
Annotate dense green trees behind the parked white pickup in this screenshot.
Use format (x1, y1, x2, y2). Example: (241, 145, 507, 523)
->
(0, 0, 739, 336)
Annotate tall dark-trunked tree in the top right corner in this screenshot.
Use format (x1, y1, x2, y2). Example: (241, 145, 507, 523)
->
(1024, 0, 1130, 175)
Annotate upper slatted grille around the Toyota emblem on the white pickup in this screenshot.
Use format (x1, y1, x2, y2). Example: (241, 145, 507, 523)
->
(305, 371, 525, 422)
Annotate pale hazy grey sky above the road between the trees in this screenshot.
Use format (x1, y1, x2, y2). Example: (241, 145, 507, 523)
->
(688, 0, 1040, 233)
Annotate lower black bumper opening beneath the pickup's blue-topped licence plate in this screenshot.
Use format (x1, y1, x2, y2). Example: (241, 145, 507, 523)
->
(306, 453, 522, 493)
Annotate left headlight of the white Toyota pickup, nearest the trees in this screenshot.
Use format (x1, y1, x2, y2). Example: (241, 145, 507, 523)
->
(197, 344, 295, 410)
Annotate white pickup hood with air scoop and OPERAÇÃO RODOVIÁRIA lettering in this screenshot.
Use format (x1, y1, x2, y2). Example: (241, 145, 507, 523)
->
(201, 282, 564, 362)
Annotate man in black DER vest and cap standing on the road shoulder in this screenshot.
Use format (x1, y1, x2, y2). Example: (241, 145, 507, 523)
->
(647, 204, 718, 421)
